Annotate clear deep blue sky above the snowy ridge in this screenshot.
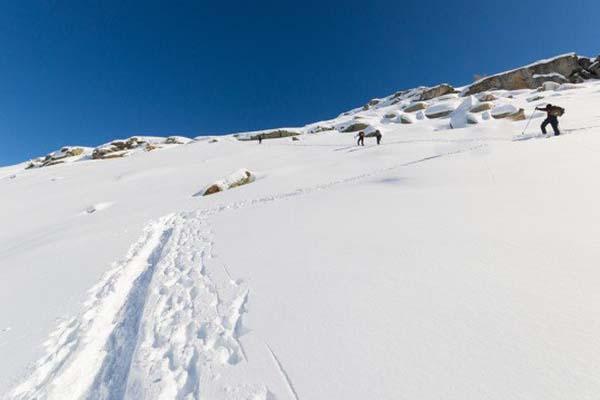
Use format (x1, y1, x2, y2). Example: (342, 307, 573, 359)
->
(0, 0, 600, 165)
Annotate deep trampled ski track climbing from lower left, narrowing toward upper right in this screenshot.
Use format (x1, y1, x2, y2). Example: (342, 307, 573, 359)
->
(8, 143, 486, 400)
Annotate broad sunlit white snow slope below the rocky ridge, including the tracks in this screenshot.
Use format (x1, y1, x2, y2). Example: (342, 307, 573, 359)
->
(0, 70, 600, 400)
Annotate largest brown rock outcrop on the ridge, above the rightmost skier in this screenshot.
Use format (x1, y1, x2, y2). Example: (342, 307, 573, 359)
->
(463, 54, 596, 95)
